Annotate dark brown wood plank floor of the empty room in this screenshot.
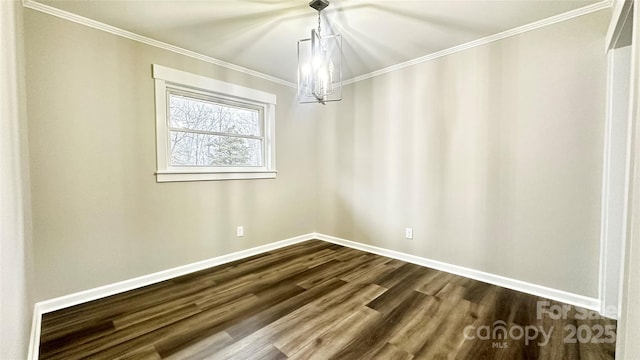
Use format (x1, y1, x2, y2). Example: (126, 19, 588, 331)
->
(40, 241, 616, 360)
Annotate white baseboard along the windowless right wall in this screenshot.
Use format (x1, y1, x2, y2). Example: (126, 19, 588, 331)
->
(314, 233, 600, 311)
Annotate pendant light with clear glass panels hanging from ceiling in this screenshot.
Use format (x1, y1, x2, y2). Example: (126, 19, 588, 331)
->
(298, 0, 342, 105)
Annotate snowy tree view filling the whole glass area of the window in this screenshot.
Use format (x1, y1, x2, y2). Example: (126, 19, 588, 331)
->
(169, 93, 263, 167)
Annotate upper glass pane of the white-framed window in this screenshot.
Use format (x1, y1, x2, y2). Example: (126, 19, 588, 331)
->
(169, 94, 261, 136)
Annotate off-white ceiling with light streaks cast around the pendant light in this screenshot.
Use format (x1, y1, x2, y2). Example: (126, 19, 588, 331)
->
(37, 0, 597, 82)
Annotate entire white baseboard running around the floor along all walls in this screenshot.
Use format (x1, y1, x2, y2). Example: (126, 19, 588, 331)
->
(28, 233, 600, 360)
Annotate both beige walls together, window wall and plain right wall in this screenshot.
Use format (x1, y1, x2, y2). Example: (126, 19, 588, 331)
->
(25, 10, 608, 300)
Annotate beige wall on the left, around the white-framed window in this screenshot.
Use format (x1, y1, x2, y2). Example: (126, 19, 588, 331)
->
(25, 10, 315, 300)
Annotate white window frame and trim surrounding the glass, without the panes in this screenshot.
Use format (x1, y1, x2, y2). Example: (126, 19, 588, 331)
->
(153, 64, 277, 182)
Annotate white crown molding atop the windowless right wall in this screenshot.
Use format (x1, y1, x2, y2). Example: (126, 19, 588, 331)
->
(342, 0, 613, 85)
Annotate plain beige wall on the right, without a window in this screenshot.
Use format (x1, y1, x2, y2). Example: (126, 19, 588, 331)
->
(316, 11, 610, 297)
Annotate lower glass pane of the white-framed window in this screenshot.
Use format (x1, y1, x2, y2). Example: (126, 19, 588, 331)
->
(171, 131, 262, 166)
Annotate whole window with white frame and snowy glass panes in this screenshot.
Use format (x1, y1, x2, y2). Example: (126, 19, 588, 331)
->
(153, 64, 276, 182)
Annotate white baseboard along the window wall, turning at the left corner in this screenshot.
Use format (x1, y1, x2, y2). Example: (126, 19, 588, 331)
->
(28, 233, 315, 360)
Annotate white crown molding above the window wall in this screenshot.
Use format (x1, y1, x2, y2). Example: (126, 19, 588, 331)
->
(22, 0, 297, 89)
